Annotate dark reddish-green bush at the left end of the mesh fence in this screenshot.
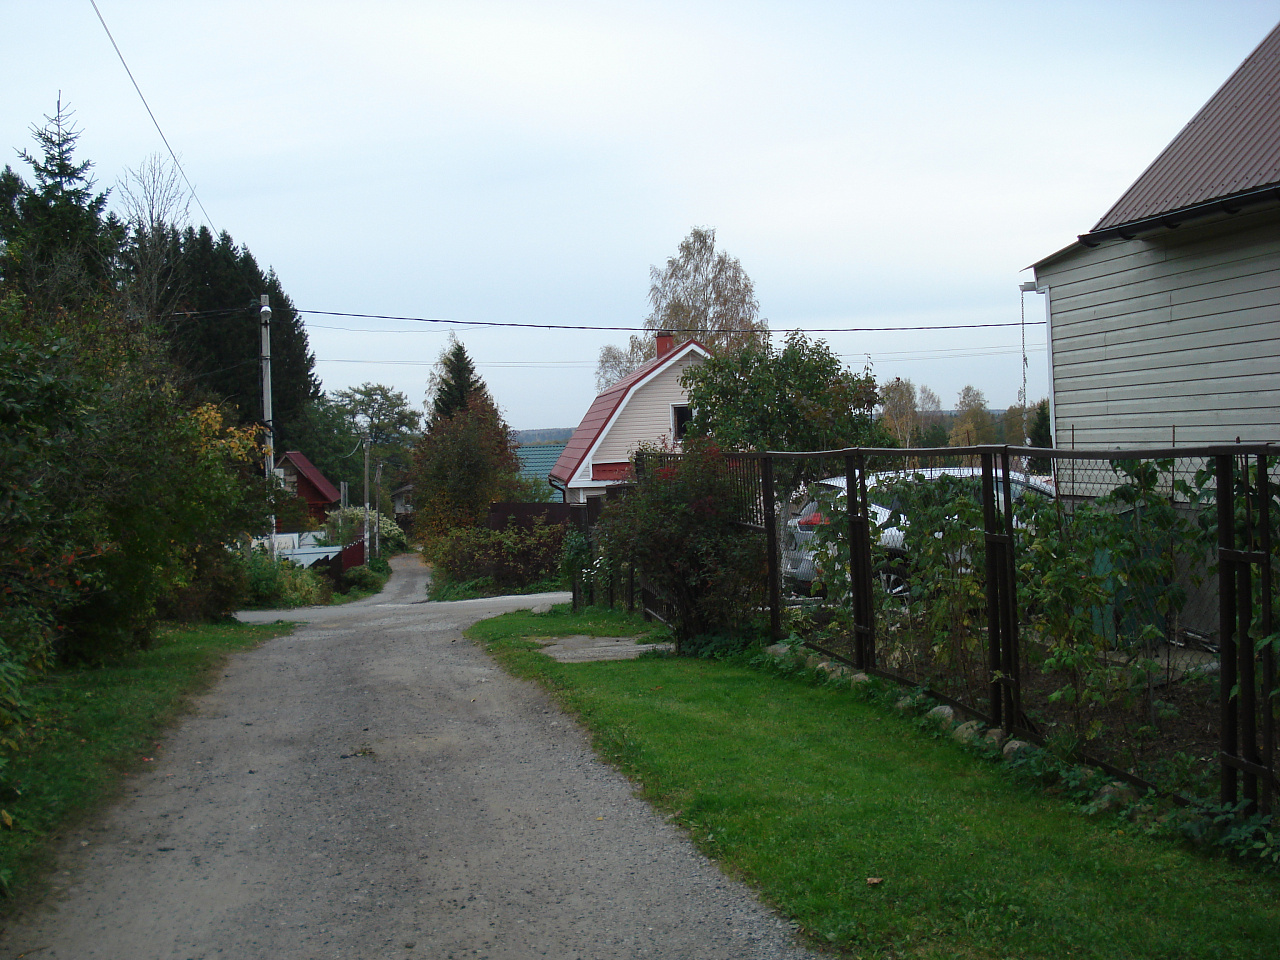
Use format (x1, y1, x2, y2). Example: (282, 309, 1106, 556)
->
(596, 440, 767, 652)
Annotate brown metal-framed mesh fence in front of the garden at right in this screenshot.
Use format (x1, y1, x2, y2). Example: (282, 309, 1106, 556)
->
(629, 444, 1280, 813)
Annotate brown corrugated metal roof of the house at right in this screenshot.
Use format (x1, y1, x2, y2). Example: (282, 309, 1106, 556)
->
(1082, 24, 1280, 239)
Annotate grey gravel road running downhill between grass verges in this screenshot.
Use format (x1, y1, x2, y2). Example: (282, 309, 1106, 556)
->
(0, 557, 815, 960)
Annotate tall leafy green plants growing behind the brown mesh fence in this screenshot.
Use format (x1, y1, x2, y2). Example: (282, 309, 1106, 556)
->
(798, 460, 1228, 762)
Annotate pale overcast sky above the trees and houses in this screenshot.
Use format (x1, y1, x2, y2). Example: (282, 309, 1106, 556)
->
(0, 0, 1280, 429)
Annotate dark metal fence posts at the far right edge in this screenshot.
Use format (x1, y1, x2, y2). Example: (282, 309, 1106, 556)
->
(1215, 453, 1277, 813)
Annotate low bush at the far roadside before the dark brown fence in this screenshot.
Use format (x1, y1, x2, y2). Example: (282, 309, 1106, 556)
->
(428, 517, 564, 590)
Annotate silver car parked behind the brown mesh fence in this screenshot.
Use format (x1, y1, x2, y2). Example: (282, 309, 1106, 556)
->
(782, 467, 1055, 594)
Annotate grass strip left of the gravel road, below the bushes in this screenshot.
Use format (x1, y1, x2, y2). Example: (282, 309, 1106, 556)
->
(0, 623, 292, 913)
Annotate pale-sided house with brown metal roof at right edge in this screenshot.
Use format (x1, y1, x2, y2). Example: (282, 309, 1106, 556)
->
(1034, 27, 1280, 449)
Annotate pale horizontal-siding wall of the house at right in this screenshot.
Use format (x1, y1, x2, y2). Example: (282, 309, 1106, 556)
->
(1037, 209, 1280, 449)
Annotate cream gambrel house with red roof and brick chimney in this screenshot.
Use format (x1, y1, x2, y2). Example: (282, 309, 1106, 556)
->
(548, 332, 710, 503)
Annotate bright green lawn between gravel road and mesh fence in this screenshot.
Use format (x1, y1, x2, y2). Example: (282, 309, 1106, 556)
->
(470, 608, 1280, 960)
